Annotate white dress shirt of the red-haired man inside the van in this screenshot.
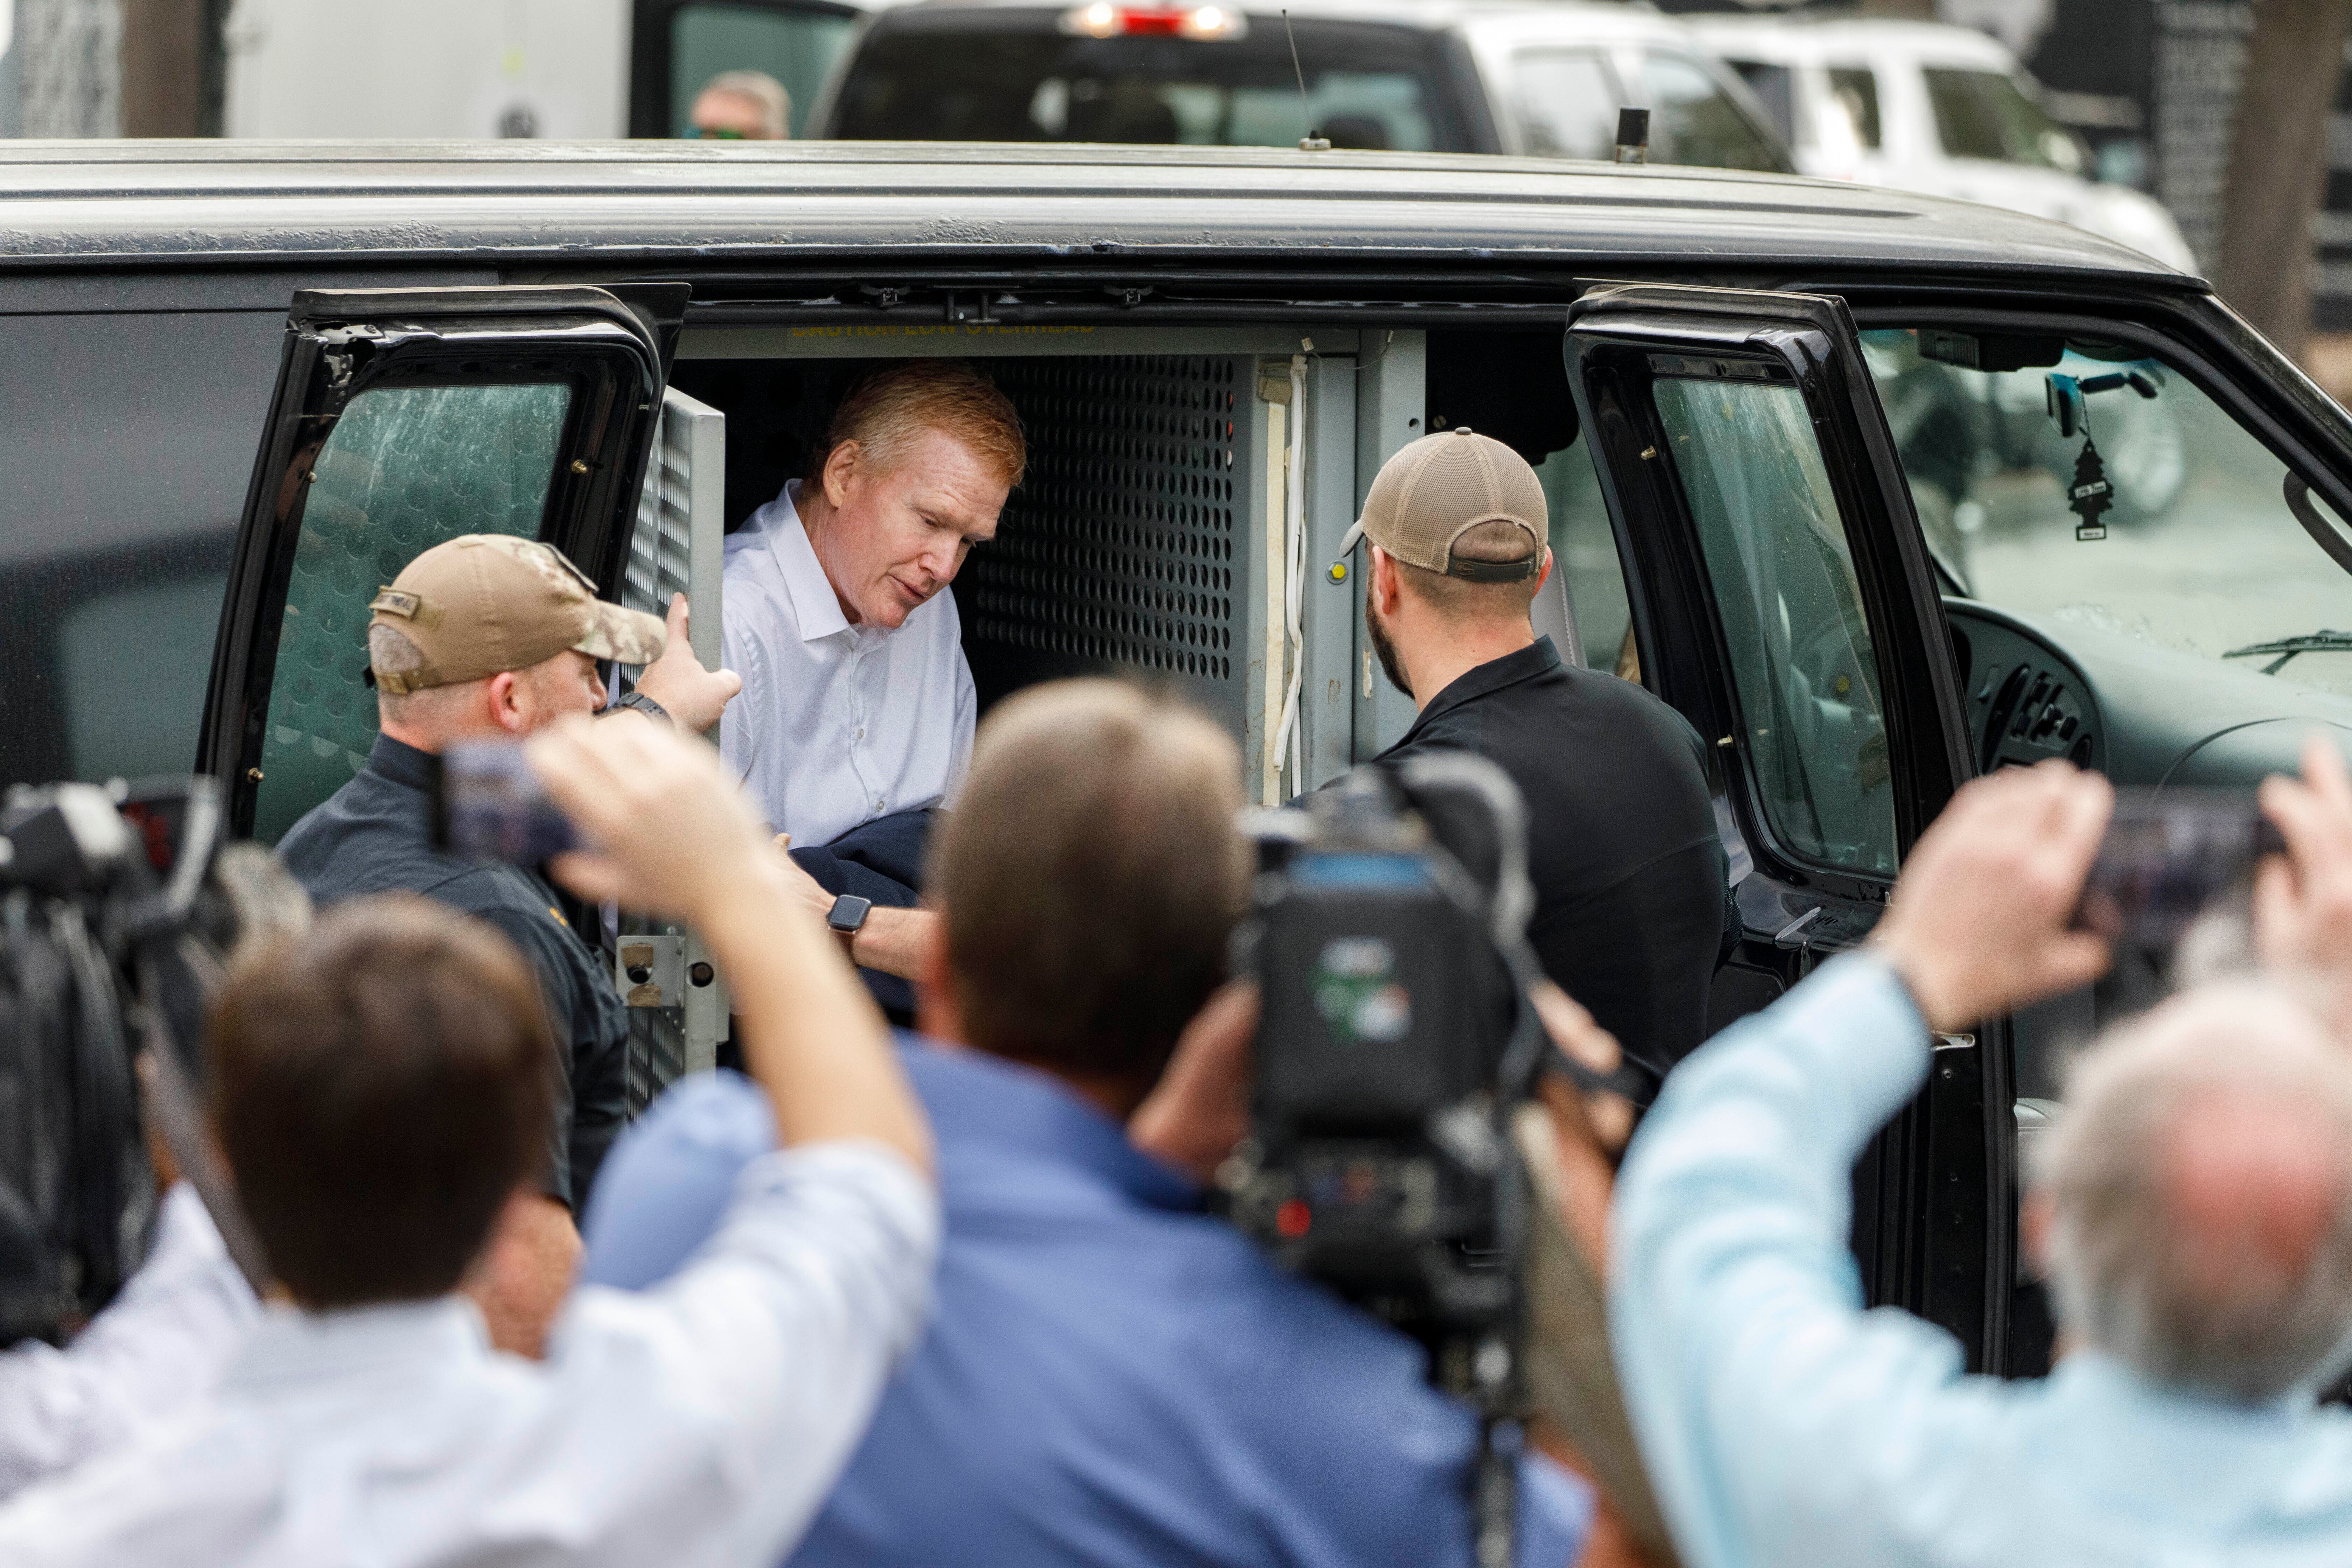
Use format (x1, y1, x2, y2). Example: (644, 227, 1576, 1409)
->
(720, 479, 979, 849)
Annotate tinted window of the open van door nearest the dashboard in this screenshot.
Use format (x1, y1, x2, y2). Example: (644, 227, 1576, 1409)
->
(1651, 378, 1896, 875)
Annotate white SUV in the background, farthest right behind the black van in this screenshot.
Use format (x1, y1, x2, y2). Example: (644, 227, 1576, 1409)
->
(1689, 12, 2197, 270)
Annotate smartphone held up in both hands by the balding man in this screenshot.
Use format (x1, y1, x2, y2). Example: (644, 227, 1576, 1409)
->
(2074, 790, 2286, 952)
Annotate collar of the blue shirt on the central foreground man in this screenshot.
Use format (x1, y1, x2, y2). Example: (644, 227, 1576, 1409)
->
(898, 1034, 1199, 1211)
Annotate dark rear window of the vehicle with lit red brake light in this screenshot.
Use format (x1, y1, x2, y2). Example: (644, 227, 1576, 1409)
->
(833, 9, 1468, 153)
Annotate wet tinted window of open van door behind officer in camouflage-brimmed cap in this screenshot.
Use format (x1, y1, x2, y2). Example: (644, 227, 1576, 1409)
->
(254, 381, 572, 844)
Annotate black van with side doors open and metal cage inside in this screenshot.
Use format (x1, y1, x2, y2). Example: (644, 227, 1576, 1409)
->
(0, 141, 2352, 1373)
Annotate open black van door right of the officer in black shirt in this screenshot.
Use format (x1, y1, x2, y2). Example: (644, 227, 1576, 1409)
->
(1567, 285, 2016, 1371)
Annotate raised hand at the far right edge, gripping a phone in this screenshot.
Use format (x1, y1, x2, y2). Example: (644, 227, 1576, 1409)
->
(2253, 736, 2352, 1030)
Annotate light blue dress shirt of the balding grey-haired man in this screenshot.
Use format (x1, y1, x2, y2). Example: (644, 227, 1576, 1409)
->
(1609, 957, 2352, 1568)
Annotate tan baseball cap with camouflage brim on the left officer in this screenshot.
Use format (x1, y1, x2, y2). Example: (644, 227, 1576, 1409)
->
(367, 534, 668, 696)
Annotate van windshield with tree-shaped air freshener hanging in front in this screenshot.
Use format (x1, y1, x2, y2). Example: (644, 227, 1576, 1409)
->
(1863, 331, 2352, 696)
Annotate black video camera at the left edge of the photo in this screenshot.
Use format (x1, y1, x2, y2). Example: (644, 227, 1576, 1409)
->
(0, 778, 267, 1345)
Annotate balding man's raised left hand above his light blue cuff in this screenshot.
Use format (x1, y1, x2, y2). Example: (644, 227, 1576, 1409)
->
(1870, 762, 2114, 1030)
